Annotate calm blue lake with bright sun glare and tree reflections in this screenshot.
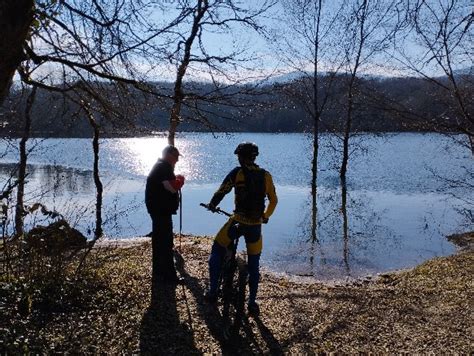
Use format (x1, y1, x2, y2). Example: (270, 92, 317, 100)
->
(0, 133, 474, 280)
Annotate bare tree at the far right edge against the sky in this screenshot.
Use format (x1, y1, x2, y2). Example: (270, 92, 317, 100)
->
(394, 0, 474, 155)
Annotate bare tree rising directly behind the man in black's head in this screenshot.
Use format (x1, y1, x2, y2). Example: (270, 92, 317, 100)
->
(164, 0, 275, 145)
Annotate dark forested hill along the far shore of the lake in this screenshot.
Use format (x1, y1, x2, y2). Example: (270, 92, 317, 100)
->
(0, 74, 474, 137)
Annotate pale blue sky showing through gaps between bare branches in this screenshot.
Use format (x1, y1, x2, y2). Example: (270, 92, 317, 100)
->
(27, 0, 474, 82)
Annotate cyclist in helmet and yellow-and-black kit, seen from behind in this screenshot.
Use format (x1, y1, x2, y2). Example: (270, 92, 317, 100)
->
(206, 142, 278, 316)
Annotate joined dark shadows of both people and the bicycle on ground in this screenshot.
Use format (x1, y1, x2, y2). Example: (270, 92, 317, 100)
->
(140, 254, 283, 355)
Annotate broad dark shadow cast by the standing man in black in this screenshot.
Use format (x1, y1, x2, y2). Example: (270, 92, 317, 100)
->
(140, 262, 201, 355)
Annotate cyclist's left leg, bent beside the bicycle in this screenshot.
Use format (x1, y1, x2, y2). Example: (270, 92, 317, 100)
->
(209, 219, 238, 297)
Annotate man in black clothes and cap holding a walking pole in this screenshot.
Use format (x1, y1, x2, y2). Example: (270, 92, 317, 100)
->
(145, 146, 184, 289)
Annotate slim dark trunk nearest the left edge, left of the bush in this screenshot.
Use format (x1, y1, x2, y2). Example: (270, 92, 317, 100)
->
(15, 86, 36, 237)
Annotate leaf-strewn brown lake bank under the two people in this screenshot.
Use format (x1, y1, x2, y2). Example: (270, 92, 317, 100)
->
(0, 234, 474, 355)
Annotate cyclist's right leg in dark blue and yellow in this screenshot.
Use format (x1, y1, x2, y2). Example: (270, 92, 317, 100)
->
(244, 225, 262, 306)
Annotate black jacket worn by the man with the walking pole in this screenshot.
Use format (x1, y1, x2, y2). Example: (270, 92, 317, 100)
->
(145, 159, 179, 215)
